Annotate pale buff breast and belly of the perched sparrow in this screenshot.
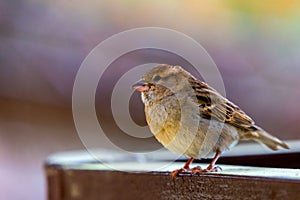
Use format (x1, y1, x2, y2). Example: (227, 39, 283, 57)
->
(145, 93, 238, 157)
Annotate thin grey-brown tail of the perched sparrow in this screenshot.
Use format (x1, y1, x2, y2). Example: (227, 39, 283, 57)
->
(252, 127, 290, 150)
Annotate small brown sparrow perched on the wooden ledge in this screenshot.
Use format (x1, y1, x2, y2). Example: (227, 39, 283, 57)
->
(132, 64, 289, 177)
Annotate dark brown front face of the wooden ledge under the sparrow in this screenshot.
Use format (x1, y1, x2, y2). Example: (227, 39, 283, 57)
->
(47, 166, 300, 200)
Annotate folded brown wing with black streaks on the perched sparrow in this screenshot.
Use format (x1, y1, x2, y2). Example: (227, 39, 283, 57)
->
(190, 79, 256, 131)
